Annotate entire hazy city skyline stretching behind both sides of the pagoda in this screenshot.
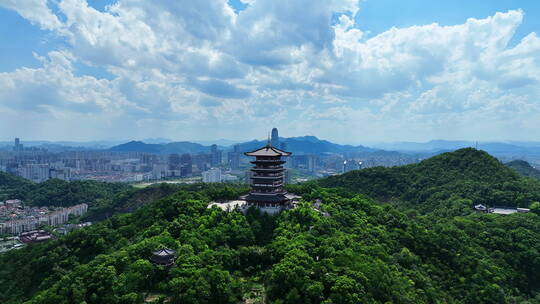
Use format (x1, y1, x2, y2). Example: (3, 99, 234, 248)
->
(0, 128, 418, 183)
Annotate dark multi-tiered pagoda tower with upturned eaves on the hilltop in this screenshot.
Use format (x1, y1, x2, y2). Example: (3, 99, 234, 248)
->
(244, 140, 292, 208)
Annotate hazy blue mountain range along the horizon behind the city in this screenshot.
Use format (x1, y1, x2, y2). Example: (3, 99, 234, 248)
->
(0, 136, 540, 162)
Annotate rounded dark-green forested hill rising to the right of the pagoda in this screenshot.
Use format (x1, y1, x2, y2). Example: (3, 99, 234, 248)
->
(318, 148, 540, 210)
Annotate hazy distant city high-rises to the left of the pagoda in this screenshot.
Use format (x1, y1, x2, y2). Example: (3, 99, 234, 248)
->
(0, 138, 247, 182)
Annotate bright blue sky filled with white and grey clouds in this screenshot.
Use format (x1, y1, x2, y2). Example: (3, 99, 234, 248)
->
(0, 0, 540, 144)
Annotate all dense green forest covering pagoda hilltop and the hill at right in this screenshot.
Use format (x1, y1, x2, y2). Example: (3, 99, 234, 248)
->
(0, 149, 540, 304)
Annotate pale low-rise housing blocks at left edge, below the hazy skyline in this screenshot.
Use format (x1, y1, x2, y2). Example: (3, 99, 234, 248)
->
(0, 200, 88, 234)
